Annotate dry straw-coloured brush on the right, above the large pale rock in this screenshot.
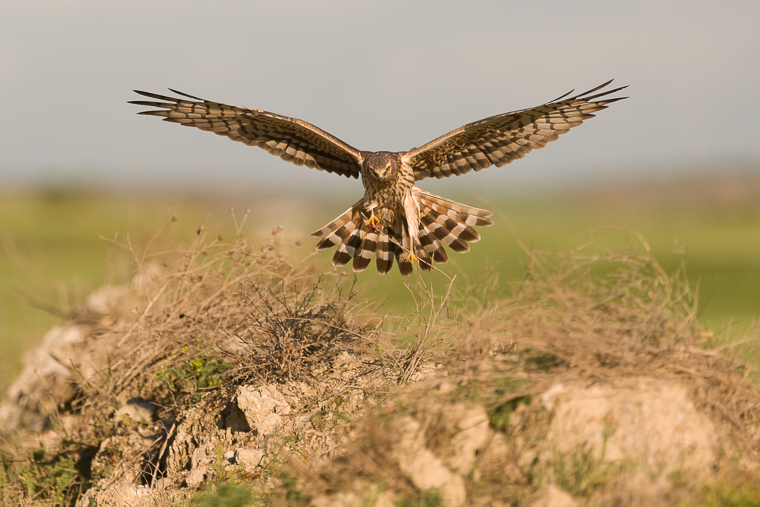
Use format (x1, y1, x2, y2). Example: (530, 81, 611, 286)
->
(458, 231, 760, 460)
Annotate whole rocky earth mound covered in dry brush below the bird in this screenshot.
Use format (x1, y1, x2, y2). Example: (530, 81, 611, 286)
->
(0, 212, 760, 506)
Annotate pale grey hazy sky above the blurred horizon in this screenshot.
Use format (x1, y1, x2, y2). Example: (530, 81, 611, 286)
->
(0, 0, 760, 193)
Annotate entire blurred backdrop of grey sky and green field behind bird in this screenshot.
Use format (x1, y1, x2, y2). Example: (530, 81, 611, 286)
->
(0, 0, 760, 389)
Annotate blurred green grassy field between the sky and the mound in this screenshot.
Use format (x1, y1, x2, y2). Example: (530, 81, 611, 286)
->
(0, 173, 760, 390)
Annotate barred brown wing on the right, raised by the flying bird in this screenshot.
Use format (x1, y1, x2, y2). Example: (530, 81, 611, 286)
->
(402, 80, 627, 181)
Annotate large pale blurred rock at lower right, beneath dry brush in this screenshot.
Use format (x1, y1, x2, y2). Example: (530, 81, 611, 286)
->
(548, 378, 718, 475)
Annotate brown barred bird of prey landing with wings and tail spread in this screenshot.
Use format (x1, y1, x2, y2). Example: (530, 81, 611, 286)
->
(130, 81, 626, 276)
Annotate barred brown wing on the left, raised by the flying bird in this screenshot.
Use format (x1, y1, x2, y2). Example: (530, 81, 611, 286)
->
(129, 90, 364, 178)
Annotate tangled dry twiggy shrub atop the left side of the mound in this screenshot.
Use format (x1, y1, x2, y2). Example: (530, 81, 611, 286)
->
(75, 212, 380, 417)
